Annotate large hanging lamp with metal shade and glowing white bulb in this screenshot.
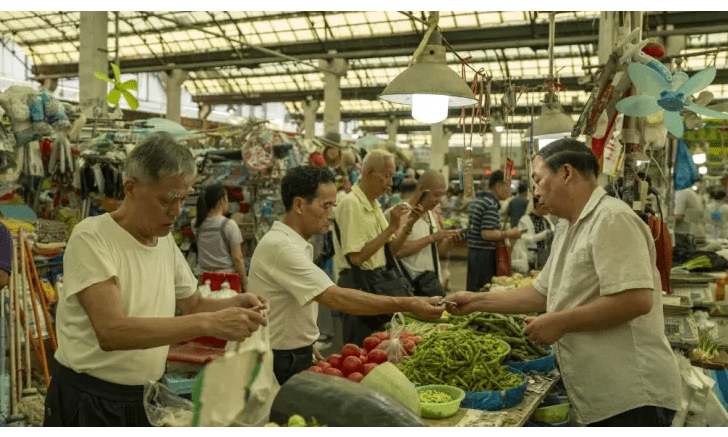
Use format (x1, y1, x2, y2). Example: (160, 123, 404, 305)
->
(379, 12, 477, 124)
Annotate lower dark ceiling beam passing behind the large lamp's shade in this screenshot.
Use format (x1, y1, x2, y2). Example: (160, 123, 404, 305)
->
(192, 69, 728, 105)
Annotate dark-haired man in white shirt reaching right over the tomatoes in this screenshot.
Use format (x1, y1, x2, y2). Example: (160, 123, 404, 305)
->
(248, 166, 444, 384)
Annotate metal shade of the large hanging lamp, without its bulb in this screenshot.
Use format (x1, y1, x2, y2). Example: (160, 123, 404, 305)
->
(379, 45, 477, 108)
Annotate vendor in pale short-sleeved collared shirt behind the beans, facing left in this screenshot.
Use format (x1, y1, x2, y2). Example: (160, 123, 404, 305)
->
(448, 139, 681, 426)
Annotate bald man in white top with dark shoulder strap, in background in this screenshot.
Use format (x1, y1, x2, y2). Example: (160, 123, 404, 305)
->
(384, 170, 460, 296)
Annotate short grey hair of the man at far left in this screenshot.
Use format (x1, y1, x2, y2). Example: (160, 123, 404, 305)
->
(123, 132, 197, 183)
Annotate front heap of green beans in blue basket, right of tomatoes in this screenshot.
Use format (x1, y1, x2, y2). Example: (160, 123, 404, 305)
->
(398, 328, 523, 391)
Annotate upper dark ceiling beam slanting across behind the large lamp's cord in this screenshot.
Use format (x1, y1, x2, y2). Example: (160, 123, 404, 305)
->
(26, 11, 728, 79)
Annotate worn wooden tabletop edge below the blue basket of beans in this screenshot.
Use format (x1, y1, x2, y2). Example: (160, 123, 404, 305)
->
(427, 370, 561, 427)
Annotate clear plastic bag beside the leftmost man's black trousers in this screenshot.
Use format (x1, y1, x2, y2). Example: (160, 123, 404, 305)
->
(144, 381, 195, 426)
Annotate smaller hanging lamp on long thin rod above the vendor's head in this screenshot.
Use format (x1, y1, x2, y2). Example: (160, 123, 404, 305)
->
(526, 12, 574, 144)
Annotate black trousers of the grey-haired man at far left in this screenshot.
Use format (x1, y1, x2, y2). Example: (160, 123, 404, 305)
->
(43, 364, 151, 427)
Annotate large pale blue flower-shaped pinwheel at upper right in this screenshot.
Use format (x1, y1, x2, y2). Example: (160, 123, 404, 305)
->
(617, 62, 728, 138)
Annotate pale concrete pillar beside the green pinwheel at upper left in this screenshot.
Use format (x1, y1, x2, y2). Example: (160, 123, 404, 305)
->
(78, 11, 113, 117)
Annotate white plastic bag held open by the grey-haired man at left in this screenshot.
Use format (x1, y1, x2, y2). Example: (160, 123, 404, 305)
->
(197, 316, 280, 426)
